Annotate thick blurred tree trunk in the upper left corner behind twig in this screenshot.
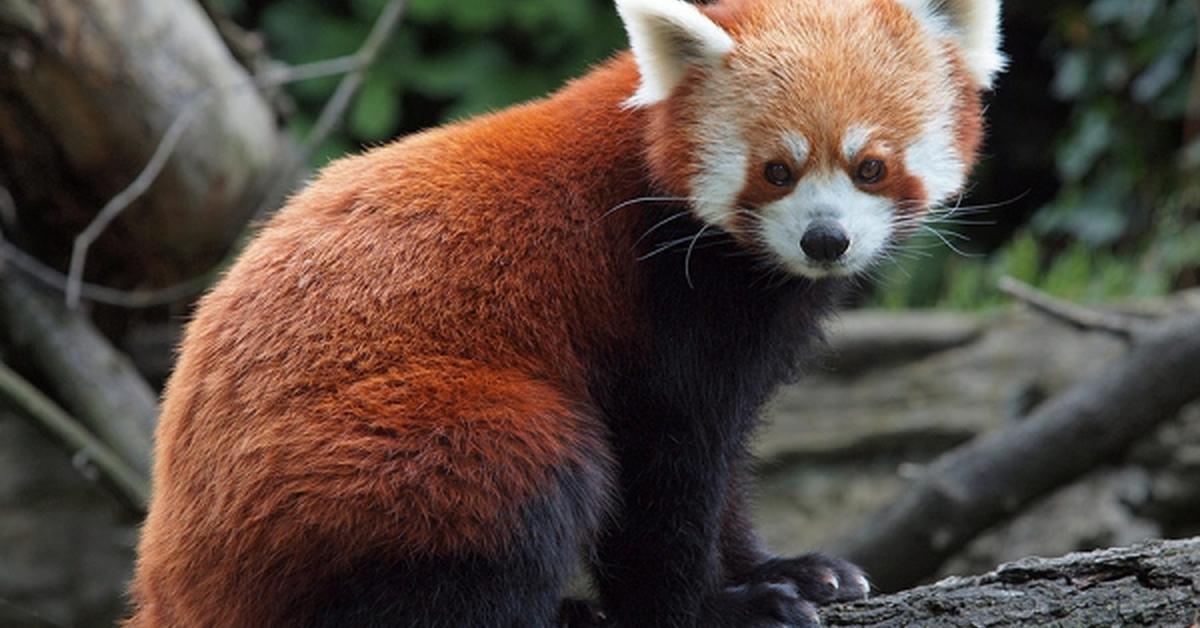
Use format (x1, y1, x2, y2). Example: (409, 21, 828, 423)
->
(0, 0, 283, 287)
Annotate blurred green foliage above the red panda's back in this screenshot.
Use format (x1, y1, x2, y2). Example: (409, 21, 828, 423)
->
(218, 0, 624, 165)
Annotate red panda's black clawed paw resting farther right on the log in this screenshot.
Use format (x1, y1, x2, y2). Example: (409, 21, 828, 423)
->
(745, 554, 871, 604)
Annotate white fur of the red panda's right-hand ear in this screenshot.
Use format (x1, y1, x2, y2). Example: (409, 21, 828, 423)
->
(900, 0, 1008, 89)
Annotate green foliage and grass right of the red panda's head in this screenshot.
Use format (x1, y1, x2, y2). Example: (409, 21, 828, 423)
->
(877, 0, 1200, 309)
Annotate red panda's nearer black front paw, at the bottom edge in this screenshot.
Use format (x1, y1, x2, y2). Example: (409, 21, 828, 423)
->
(700, 582, 821, 628)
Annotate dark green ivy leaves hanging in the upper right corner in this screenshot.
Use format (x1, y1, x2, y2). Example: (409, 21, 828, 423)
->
(1033, 0, 1196, 246)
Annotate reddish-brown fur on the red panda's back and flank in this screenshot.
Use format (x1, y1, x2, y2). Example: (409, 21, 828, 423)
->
(130, 58, 646, 627)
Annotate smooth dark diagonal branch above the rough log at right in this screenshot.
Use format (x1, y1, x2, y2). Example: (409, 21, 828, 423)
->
(839, 315, 1200, 591)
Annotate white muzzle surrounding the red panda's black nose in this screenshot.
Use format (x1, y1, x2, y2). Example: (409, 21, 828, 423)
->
(761, 171, 893, 279)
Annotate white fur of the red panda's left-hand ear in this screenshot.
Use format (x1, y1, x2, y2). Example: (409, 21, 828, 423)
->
(617, 0, 734, 107)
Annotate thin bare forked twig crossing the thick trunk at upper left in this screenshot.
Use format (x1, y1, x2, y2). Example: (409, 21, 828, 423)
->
(65, 0, 406, 309)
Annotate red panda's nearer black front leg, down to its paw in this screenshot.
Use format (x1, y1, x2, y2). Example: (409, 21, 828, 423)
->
(594, 419, 815, 628)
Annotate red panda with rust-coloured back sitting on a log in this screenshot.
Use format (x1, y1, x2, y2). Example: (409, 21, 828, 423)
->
(127, 0, 1004, 628)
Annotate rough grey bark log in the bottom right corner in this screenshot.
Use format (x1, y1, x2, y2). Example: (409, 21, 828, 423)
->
(822, 539, 1200, 628)
